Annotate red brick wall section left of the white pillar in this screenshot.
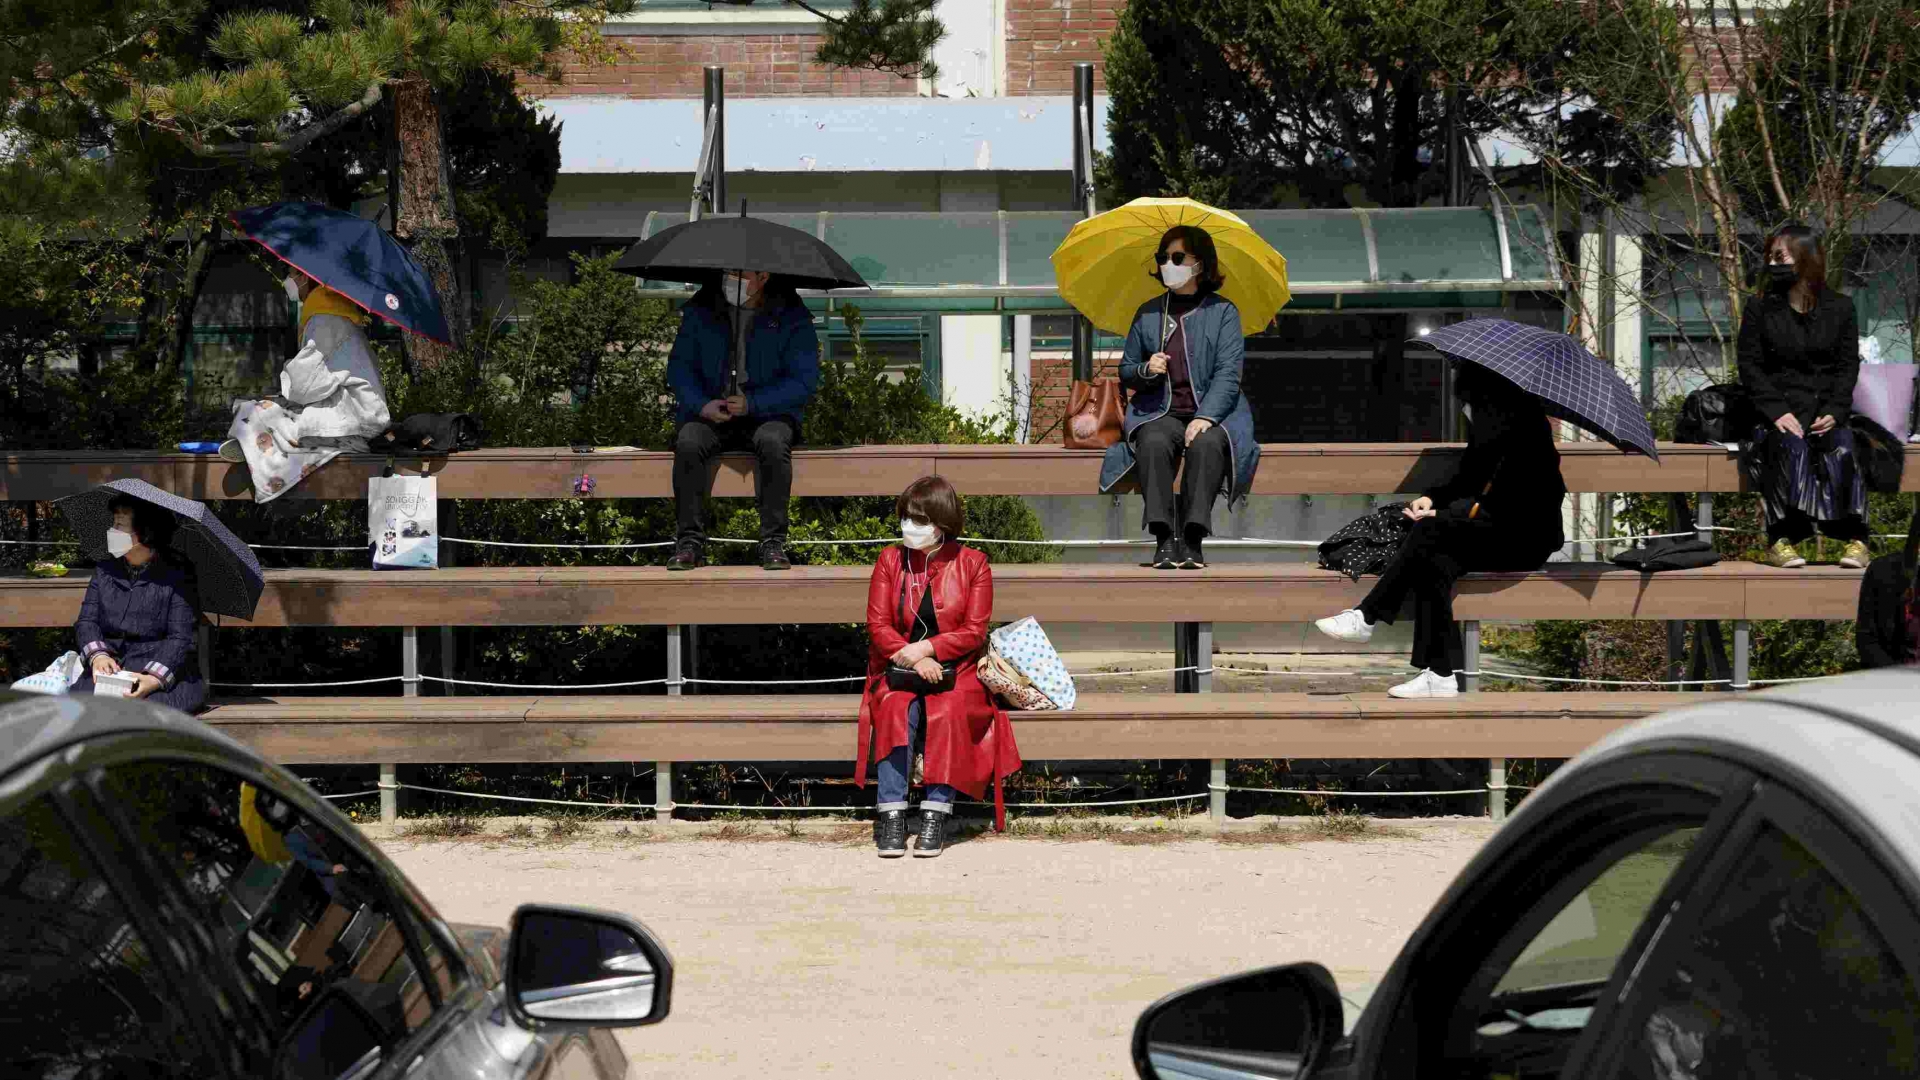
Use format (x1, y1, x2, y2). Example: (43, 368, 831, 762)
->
(532, 35, 918, 100)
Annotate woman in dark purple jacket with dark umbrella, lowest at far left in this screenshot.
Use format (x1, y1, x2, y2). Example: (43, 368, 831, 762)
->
(54, 480, 267, 713)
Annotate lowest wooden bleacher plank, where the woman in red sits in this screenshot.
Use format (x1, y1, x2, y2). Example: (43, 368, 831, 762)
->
(202, 694, 1674, 765)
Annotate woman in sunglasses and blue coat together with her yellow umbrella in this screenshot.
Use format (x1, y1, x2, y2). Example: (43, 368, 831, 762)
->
(1054, 198, 1288, 571)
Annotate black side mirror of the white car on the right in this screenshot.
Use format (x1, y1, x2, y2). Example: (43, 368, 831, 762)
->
(1133, 963, 1346, 1080)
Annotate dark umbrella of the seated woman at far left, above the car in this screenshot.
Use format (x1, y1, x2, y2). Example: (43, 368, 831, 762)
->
(54, 480, 267, 619)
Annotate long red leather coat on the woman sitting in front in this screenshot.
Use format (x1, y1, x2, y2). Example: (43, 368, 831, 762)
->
(852, 540, 1020, 830)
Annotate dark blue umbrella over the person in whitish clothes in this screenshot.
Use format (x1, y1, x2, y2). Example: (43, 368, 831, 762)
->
(234, 202, 451, 344)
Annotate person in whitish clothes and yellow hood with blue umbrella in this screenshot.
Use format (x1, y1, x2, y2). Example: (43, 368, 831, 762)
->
(221, 202, 447, 502)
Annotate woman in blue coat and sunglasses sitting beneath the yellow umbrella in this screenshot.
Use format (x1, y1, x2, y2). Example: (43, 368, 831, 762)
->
(1100, 225, 1260, 571)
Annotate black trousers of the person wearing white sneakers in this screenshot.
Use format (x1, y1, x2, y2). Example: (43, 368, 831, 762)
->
(1359, 513, 1563, 675)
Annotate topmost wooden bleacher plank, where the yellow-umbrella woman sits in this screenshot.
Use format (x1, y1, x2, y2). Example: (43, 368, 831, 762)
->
(0, 442, 1920, 502)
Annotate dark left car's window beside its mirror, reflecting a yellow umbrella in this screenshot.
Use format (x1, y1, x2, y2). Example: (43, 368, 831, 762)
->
(106, 761, 465, 1076)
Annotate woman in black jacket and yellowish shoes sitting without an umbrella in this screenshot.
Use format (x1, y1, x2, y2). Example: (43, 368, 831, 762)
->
(1740, 225, 1870, 569)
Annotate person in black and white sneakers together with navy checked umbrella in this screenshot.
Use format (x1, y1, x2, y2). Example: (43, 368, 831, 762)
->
(1315, 319, 1659, 698)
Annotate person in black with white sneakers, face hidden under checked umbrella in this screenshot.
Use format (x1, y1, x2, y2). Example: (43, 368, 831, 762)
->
(1315, 359, 1567, 698)
